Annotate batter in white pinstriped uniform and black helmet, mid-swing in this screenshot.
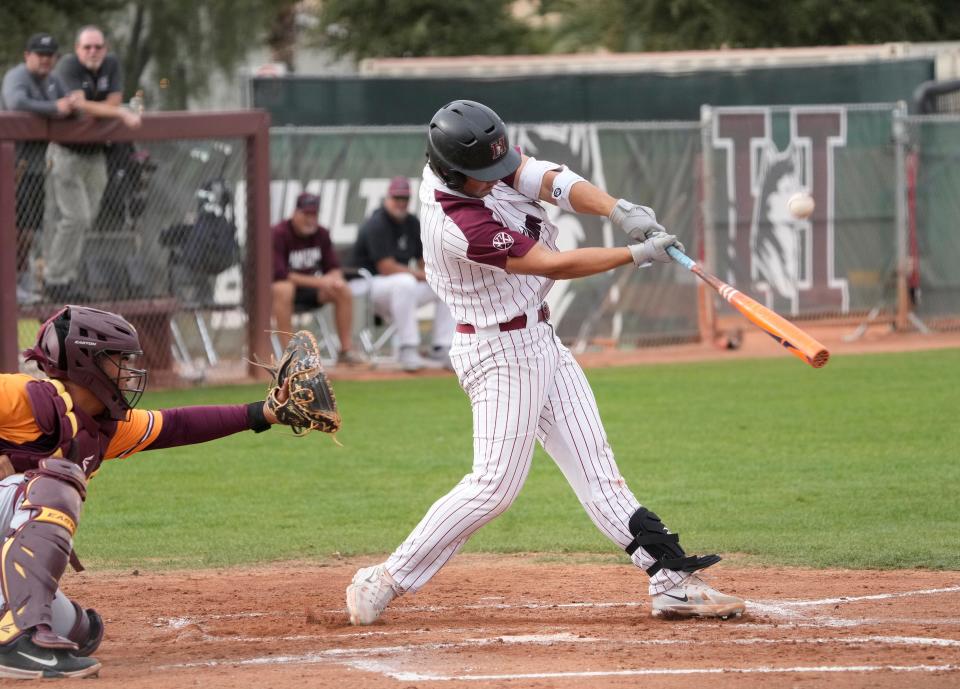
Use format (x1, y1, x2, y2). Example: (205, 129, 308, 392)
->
(347, 100, 744, 624)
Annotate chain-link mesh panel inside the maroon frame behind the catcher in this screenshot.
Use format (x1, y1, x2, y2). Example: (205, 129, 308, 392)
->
(0, 113, 269, 379)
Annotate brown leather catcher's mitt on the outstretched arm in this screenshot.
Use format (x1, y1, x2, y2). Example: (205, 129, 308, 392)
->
(267, 330, 340, 435)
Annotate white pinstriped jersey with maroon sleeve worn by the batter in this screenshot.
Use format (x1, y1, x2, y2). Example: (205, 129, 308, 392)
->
(420, 166, 557, 328)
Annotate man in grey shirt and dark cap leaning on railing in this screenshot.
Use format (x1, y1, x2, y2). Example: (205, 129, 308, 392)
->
(0, 33, 76, 303)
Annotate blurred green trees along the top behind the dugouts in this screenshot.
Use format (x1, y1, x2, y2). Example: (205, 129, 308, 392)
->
(0, 0, 960, 109)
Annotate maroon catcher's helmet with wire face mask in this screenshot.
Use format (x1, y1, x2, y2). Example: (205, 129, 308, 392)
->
(23, 306, 147, 421)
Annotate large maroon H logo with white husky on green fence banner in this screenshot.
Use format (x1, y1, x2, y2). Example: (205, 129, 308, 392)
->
(712, 107, 849, 314)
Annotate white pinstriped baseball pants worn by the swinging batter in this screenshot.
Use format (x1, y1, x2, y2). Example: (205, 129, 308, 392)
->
(386, 323, 682, 594)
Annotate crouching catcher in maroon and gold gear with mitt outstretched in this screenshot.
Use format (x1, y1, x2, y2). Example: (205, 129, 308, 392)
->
(0, 306, 340, 679)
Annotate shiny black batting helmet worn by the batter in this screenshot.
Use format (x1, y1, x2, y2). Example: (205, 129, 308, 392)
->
(427, 100, 520, 189)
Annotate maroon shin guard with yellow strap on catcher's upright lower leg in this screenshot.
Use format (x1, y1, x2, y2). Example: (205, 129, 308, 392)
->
(0, 459, 86, 650)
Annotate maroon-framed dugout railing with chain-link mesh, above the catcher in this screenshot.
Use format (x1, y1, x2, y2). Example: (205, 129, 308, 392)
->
(0, 110, 272, 380)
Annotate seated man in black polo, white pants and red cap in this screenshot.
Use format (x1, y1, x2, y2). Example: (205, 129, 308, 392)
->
(354, 177, 456, 371)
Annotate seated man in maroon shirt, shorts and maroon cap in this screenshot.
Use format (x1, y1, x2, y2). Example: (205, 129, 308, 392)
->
(271, 193, 365, 366)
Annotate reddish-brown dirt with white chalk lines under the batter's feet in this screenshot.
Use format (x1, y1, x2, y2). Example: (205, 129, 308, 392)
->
(64, 555, 960, 689)
